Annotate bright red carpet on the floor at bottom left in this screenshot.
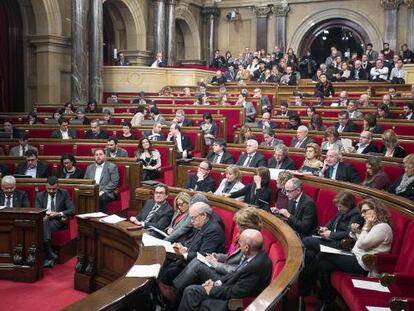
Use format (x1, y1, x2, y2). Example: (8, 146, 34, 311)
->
(0, 257, 87, 311)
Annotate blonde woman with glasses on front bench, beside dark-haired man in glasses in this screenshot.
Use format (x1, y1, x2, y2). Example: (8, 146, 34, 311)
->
(164, 192, 193, 242)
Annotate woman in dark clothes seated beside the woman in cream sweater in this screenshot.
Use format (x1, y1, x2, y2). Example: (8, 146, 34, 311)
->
(300, 191, 363, 296)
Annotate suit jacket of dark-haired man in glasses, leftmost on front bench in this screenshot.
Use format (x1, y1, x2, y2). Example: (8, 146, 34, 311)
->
(137, 200, 174, 231)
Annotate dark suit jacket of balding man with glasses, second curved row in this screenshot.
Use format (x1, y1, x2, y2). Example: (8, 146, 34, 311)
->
(287, 192, 318, 237)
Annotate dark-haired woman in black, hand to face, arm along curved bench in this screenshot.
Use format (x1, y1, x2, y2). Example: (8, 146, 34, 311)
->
(225, 166, 272, 212)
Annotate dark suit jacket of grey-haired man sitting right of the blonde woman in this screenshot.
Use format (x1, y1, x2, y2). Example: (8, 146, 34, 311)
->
(183, 216, 225, 262)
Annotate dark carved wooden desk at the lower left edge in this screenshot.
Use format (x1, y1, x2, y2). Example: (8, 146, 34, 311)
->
(0, 208, 46, 282)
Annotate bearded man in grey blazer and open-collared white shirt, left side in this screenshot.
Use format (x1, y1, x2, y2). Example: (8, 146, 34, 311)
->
(83, 148, 119, 213)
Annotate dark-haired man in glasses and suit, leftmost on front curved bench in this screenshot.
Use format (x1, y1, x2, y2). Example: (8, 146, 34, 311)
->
(130, 184, 174, 233)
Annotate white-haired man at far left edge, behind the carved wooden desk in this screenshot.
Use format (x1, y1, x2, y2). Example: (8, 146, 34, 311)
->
(0, 175, 30, 208)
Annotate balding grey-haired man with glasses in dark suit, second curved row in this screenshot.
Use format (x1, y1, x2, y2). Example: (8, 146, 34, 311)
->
(278, 177, 318, 237)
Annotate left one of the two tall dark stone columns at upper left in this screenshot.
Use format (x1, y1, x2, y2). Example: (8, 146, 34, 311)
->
(71, 0, 88, 105)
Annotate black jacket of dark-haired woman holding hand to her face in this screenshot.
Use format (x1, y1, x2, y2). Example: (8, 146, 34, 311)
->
(230, 183, 272, 212)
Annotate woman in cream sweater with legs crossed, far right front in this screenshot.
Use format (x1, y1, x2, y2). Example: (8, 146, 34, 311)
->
(318, 198, 393, 309)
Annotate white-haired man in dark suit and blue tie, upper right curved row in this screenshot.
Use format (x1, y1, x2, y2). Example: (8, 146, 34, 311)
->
(319, 149, 361, 184)
